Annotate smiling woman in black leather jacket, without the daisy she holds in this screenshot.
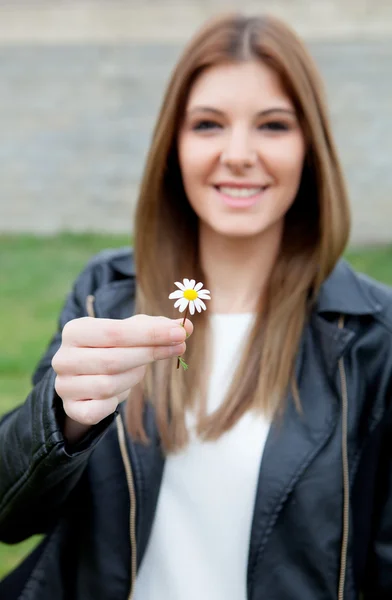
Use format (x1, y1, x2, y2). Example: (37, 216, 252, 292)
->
(0, 10, 392, 600)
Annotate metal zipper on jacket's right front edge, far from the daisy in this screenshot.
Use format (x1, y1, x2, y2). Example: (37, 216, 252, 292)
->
(338, 315, 350, 600)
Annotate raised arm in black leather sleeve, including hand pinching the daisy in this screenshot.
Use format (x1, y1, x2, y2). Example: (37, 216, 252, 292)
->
(0, 255, 192, 543)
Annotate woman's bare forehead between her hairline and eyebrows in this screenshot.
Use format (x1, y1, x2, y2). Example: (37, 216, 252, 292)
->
(187, 60, 293, 110)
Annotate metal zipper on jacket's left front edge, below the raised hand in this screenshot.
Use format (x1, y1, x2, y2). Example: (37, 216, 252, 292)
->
(86, 295, 137, 600)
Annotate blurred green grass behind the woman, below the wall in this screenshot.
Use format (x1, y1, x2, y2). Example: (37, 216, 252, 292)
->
(0, 234, 392, 578)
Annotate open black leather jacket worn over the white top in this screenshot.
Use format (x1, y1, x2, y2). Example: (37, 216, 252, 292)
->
(0, 249, 392, 600)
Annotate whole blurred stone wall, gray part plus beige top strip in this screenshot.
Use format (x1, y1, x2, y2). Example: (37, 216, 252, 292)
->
(0, 0, 392, 244)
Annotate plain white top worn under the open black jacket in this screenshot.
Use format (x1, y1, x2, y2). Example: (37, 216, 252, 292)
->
(134, 314, 270, 600)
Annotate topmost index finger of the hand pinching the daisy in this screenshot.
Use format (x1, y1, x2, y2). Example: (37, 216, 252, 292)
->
(62, 315, 193, 348)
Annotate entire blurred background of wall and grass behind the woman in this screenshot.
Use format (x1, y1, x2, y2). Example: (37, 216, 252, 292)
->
(0, 0, 392, 577)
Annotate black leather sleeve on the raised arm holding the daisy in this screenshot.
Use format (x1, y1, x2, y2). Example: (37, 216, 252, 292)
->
(0, 258, 113, 543)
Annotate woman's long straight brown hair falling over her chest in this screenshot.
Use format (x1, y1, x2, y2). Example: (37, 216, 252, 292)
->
(127, 15, 350, 452)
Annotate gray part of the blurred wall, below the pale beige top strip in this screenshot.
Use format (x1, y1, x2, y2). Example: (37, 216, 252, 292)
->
(0, 0, 392, 244)
